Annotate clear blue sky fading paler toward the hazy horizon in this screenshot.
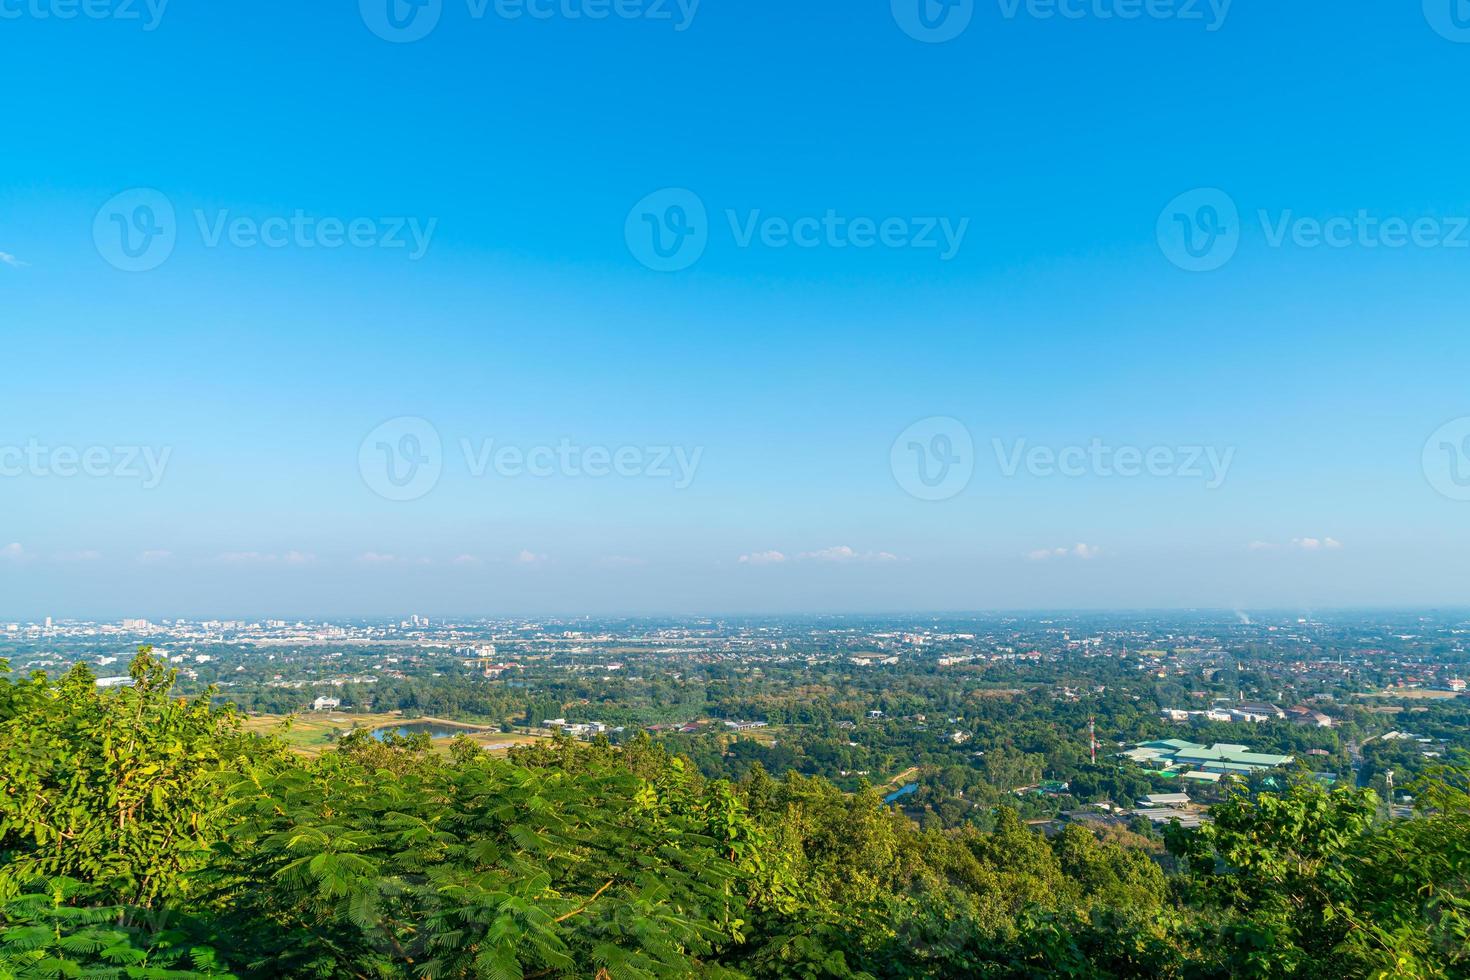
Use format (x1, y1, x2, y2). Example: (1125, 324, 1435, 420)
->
(0, 0, 1470, 617)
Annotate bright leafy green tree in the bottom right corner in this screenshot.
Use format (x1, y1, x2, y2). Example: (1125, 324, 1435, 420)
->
(1169, 768, 1470, 977)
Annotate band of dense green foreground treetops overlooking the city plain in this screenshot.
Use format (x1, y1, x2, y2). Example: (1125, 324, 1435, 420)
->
(0, 649, 1470, 980)
